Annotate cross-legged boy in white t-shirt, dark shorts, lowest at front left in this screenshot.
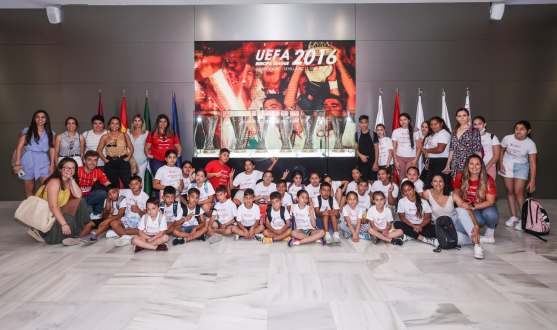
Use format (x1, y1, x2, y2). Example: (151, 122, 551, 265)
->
(132, 197, 169, 252)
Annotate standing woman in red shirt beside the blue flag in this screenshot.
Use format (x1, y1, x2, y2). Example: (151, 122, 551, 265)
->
(145, 115, 182, 177)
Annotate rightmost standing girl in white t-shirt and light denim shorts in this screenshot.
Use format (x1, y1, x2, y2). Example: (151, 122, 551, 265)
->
(499, 120, 538, 230)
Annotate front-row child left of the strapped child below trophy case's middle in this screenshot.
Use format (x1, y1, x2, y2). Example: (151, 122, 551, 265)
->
(230, 188, 265, 240)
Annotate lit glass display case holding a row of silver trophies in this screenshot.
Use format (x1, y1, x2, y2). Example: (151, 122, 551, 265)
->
(193, 110, 357, 158)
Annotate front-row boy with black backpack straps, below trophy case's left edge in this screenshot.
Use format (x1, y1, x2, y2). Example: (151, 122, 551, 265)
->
(172, 188, 207, 245)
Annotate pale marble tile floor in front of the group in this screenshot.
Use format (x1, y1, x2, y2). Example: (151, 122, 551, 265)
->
(0, 200, 557, 330)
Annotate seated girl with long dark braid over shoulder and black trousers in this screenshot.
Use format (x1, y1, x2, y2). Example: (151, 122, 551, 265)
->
(394, 180, 439, 248)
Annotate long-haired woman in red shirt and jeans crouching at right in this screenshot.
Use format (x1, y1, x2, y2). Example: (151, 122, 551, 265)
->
(453, 155, 499, 244)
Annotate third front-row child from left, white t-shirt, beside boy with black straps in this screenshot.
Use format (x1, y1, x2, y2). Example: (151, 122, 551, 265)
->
(207, 185, 238, 244)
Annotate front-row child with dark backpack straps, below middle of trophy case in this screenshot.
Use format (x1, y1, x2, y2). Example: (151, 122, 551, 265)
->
(255, 191, 292, 243)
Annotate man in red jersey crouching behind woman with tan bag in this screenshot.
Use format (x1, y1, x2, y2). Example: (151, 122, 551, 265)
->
(77, 150, 110, 220)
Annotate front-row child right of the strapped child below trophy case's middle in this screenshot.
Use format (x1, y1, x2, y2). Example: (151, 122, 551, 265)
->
(288, 189, 325, 246)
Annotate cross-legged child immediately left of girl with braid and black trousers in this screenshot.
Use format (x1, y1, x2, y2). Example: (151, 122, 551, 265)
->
(366, 191, 402, 245)
